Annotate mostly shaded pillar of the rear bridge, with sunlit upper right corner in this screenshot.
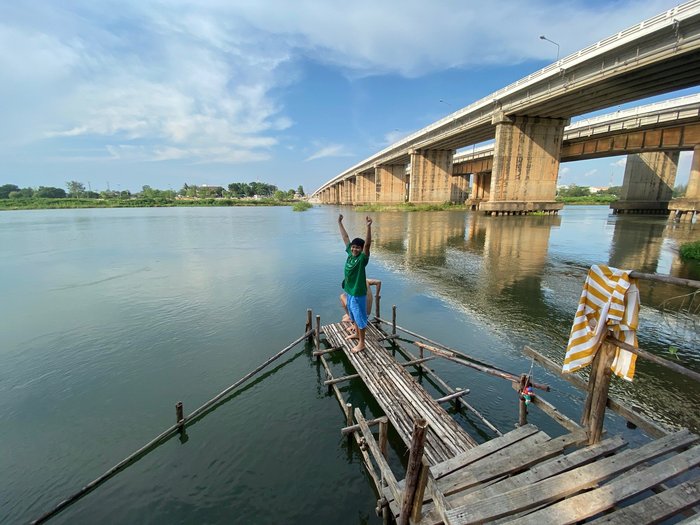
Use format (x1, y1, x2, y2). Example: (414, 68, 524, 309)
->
(610, 151, 679, 215)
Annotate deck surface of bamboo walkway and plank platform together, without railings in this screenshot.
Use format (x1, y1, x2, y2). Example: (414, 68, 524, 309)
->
(322, 323, 700, 525)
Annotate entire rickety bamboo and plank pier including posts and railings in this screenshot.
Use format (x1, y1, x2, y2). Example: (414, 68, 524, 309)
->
(316, 272, 700, 525)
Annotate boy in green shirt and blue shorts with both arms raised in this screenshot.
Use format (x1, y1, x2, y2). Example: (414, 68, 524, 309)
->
(338, 214, 372, 353)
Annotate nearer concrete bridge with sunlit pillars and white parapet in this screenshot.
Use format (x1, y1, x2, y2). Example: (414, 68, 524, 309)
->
(312, 0, 700, 218)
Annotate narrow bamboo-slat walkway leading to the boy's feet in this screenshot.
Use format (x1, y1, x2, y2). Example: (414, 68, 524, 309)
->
(322, 323, 477, 465)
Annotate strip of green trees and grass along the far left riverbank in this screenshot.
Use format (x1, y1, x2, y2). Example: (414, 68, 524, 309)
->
(0, 181, 304, 210)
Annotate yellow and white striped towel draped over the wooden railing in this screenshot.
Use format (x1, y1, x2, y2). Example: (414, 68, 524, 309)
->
(562, 264, 639, 381)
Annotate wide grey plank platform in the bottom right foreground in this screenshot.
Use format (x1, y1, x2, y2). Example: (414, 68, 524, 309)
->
(384, 425, 700, 525)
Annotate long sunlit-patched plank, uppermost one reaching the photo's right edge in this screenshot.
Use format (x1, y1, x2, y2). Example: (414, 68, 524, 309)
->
(448, 430, 699, 524)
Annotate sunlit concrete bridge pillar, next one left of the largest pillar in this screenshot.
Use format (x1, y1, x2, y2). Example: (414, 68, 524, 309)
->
(408, 149, 454, 203)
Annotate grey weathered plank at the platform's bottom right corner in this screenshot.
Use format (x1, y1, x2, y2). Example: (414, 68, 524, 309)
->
(586, 479, 700, 525)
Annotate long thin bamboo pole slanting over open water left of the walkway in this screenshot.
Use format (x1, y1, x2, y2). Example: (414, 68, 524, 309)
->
(32, 330, 313, 524)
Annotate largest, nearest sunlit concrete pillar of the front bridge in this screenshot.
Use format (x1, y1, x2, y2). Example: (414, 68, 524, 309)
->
(479, 113, 569, 214)
